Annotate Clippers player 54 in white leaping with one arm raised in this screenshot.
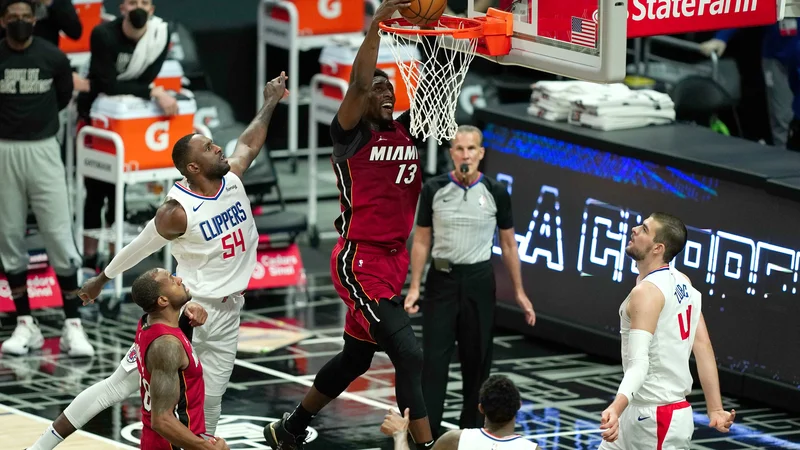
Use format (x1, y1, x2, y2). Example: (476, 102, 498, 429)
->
(31, 73, 289, 450)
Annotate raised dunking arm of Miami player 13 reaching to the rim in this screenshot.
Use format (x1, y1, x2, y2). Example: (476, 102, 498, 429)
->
(337, 0, 411, 131)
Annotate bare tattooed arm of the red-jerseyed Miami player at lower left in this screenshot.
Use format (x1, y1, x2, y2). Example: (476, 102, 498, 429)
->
(148, 336, 227, 450)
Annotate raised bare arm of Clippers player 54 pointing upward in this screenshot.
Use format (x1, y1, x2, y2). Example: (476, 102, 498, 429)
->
(228, 72, 296, 178)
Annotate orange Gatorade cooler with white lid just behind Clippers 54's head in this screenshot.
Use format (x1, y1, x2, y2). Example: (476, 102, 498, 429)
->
(88, 95, 197, 170)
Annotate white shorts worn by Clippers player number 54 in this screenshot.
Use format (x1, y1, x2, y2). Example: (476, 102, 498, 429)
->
(120, 294, 244, 397)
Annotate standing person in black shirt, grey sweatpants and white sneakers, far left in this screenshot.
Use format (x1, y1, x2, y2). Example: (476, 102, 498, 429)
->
(0, 0, 94, 356)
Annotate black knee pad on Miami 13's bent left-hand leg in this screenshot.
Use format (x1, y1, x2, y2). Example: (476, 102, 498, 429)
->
(314, 339, 375, 398)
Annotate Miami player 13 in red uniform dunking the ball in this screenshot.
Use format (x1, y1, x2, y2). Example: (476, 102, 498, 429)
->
(264, 0, 433, 450)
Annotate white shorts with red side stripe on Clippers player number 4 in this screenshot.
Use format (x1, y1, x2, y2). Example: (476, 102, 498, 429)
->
(599, 400, 694, 450)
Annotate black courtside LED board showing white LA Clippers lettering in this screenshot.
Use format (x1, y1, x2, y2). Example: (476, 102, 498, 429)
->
(484, 123, 800, 386)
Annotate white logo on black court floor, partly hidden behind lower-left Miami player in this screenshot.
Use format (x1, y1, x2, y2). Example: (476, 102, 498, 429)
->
(120, 415, 318, 450)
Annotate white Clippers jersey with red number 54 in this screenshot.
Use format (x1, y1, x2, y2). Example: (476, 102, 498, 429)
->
(167, 172, 258, 299)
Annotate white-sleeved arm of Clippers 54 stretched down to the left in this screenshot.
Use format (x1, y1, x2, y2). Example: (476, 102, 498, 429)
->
(78, 200, 186, 305)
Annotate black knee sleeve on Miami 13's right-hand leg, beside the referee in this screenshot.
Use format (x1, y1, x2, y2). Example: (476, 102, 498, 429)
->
(378, 324, 428, 420)
